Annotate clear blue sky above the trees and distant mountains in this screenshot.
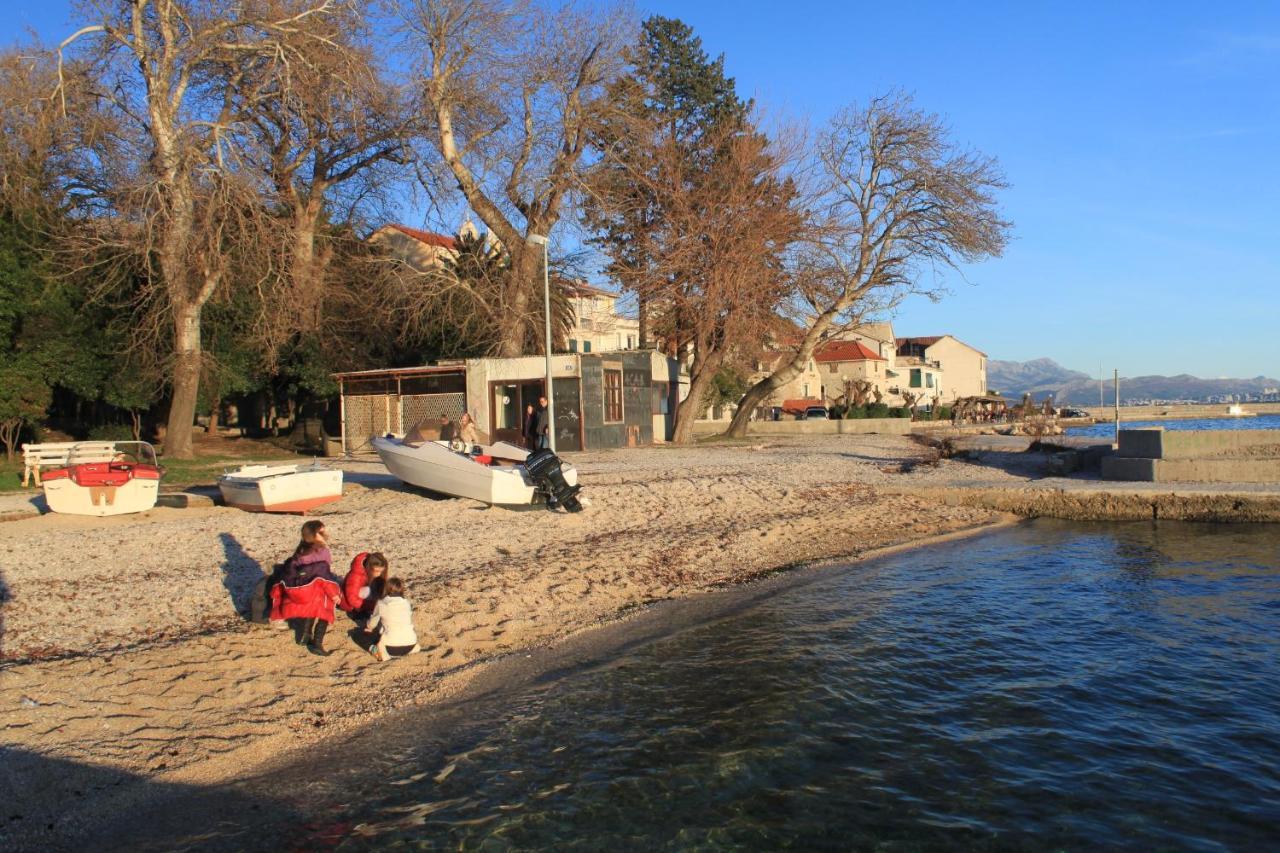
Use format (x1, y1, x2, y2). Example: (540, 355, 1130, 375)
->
(0, 0, 1280, 377)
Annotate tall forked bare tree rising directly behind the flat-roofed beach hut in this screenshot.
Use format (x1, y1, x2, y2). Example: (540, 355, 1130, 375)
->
(399, 0, 627, 356)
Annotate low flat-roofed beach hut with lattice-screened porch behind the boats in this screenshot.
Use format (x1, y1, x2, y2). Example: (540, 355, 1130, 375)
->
(334, 350, 681, 453)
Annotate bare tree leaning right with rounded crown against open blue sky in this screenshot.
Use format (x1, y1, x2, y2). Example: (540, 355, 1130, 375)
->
(727, 96, 1011, 437)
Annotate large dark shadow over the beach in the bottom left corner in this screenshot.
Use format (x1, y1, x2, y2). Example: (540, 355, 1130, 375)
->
(0, 747, 301, 852)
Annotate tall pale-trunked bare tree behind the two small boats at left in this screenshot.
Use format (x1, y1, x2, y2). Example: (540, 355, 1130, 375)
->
(58, 0, 338, 459)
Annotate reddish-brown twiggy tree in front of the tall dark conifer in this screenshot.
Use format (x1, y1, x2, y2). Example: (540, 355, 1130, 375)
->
(589, 118, 801, 443)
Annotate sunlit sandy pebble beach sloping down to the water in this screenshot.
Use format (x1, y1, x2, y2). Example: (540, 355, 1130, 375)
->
(0, 435, 1039, 838)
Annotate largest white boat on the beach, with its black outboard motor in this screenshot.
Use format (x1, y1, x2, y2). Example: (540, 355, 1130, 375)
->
(372, 437, 581, 512)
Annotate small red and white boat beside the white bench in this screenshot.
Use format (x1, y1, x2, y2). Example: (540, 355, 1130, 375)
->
(41, 442, 161, 515)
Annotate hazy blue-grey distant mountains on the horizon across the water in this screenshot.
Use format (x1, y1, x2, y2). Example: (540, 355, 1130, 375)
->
(987, 359, 1280, 406)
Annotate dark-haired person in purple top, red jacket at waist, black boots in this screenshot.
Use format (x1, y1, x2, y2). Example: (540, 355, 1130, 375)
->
(271, 521, 342, 657)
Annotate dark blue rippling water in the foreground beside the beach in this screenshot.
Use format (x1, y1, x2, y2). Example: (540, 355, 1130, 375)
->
(288, 521, 1280, 850)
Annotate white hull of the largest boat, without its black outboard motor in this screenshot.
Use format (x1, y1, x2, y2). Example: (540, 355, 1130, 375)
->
(372, 438, 577, 506)
